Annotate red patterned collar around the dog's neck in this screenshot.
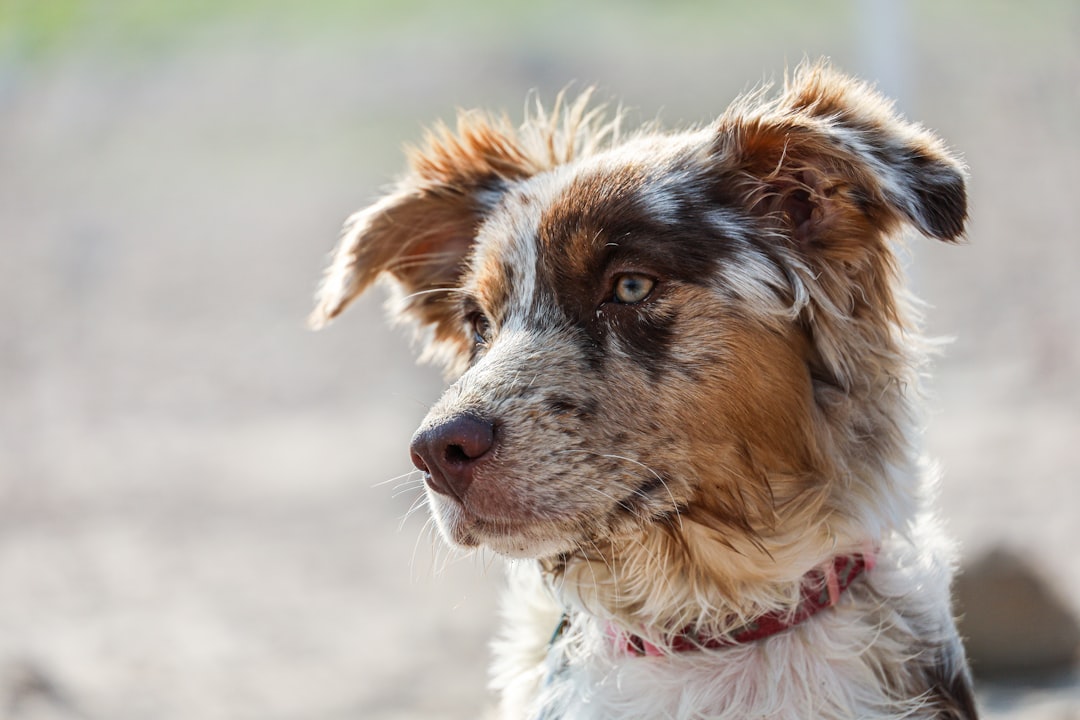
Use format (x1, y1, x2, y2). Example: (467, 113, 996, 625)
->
(552, 553, 874, 656)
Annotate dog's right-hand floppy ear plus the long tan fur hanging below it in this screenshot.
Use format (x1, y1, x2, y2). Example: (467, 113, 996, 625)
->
(712, 64, 968, 389)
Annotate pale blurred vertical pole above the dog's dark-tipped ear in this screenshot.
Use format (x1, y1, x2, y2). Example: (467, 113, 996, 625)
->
(854, 0, 914, 114)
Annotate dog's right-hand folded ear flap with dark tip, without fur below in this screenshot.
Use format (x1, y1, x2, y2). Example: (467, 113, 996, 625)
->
(716, 64, 968, 255)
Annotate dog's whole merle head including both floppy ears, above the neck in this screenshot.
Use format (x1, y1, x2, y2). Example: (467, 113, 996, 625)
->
(315, 63, 966, 558)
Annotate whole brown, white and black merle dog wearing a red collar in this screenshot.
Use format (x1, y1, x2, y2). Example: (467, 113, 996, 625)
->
(311, 63, 976, 720)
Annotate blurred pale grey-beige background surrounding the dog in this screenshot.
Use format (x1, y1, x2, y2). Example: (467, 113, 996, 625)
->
(0, 0, 1080, 720)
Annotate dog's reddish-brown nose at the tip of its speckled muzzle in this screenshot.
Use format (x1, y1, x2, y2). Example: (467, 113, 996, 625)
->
(410, 415, 495, 500)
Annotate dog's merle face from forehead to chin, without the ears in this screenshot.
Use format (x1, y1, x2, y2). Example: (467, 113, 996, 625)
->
(413, 140, 810, 556)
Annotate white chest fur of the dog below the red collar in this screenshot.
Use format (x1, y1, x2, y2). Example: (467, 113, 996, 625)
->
(492, 505, 959, 720)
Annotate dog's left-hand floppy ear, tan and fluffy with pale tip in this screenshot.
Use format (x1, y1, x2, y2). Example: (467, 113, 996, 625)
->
(309, 112, 538, 367)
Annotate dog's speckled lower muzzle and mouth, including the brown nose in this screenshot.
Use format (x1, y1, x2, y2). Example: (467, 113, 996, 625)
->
(410, 412, 683, 558)
